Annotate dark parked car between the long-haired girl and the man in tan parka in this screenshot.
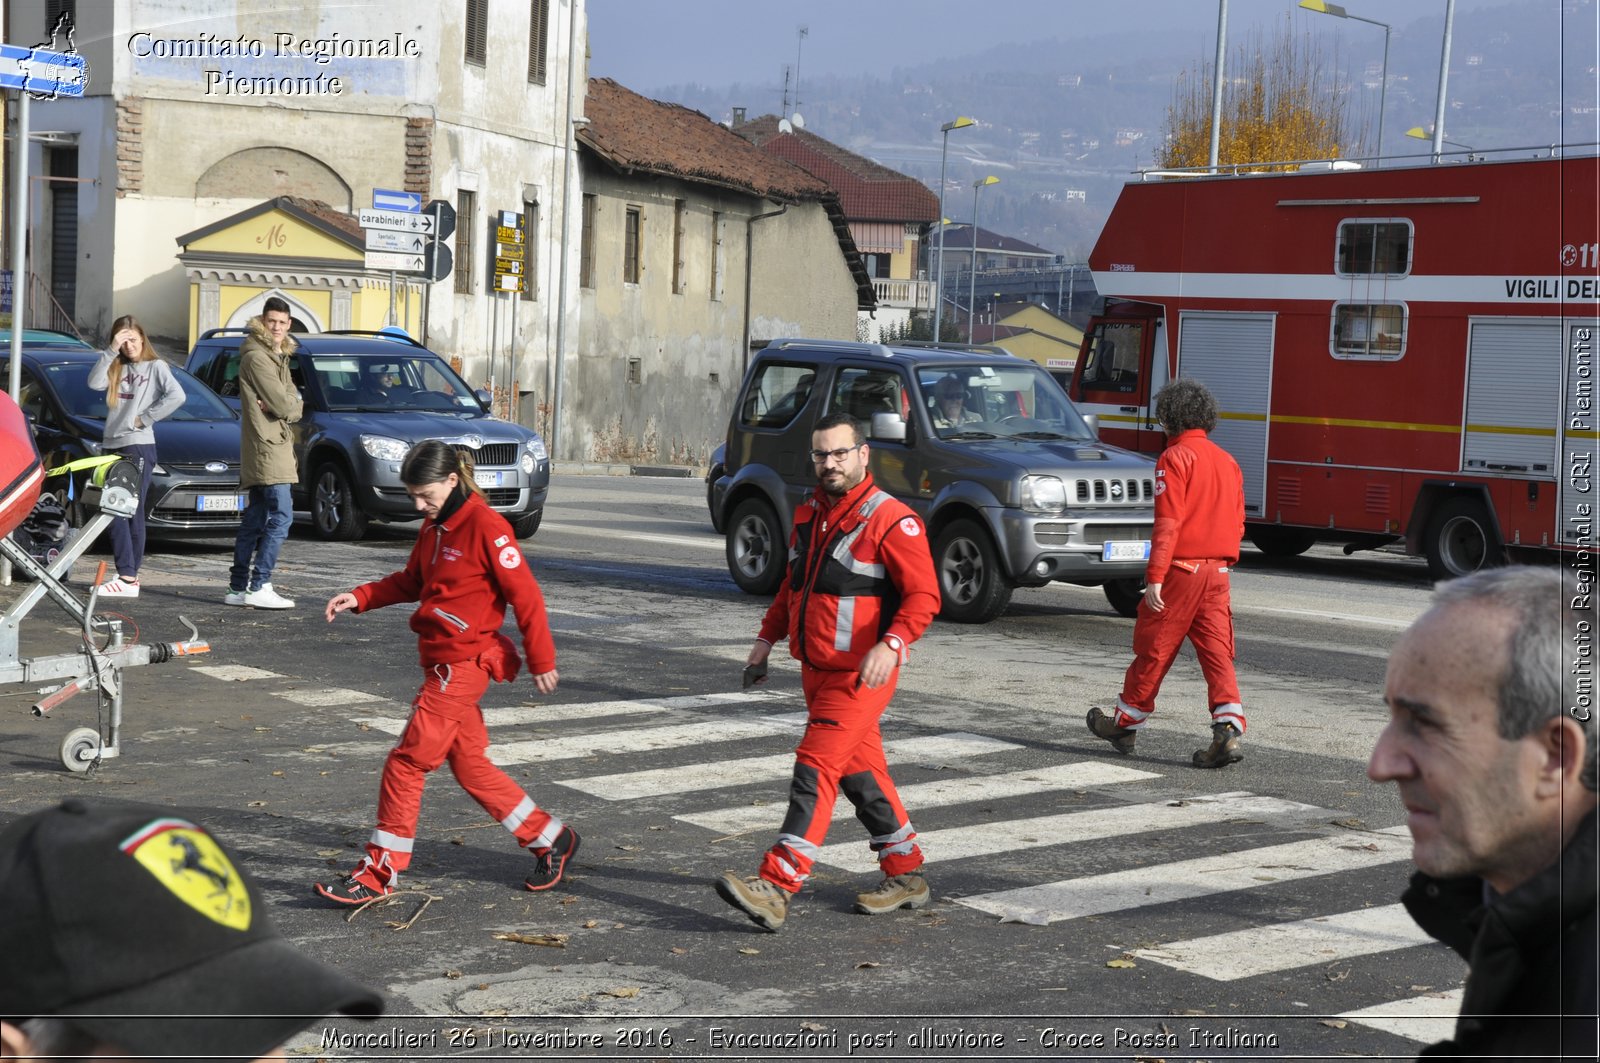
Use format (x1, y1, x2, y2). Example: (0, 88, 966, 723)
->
(0, 330, 243, 536)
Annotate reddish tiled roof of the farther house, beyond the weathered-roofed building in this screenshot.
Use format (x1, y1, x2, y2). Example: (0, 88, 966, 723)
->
(734, 115, 939, 223)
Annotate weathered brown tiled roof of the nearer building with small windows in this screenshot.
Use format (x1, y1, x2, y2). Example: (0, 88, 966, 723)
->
(578, 77, 832, 202)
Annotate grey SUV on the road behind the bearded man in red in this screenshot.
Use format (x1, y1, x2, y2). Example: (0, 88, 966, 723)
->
(707, 339, 1155, 623)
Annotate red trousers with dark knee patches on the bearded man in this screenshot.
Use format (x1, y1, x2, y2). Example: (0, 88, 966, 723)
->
(760, 666, 922, 893)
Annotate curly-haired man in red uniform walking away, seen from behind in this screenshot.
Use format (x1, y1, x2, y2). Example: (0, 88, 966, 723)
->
(1088, 379, 1245, 768)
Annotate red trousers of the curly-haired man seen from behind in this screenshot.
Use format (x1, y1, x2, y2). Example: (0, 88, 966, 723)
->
(1117, 559, 1245, 735)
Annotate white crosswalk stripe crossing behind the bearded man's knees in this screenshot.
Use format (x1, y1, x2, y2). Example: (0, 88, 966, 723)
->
(555, 732, 1019, 800)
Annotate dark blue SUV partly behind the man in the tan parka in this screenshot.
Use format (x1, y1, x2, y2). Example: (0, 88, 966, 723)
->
(187, 328, 550, 540)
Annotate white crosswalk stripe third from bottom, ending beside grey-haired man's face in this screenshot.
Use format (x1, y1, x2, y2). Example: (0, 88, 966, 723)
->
(957, 826, 1411, 925)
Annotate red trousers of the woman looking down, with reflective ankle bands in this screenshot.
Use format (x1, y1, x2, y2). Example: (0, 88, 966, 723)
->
(355, 660, 562, 885)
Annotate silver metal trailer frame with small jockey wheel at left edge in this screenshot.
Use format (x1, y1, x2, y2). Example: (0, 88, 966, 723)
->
(0, 459, 211, 772)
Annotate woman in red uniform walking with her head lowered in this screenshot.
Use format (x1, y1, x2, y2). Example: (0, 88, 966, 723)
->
(317, 439, 578, 905)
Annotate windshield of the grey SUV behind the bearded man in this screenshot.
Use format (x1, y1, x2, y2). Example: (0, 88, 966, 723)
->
(917, 360, 1094, 442)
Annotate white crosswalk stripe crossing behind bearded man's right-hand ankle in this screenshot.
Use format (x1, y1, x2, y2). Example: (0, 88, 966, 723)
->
(816, 792, 1333, 877)
